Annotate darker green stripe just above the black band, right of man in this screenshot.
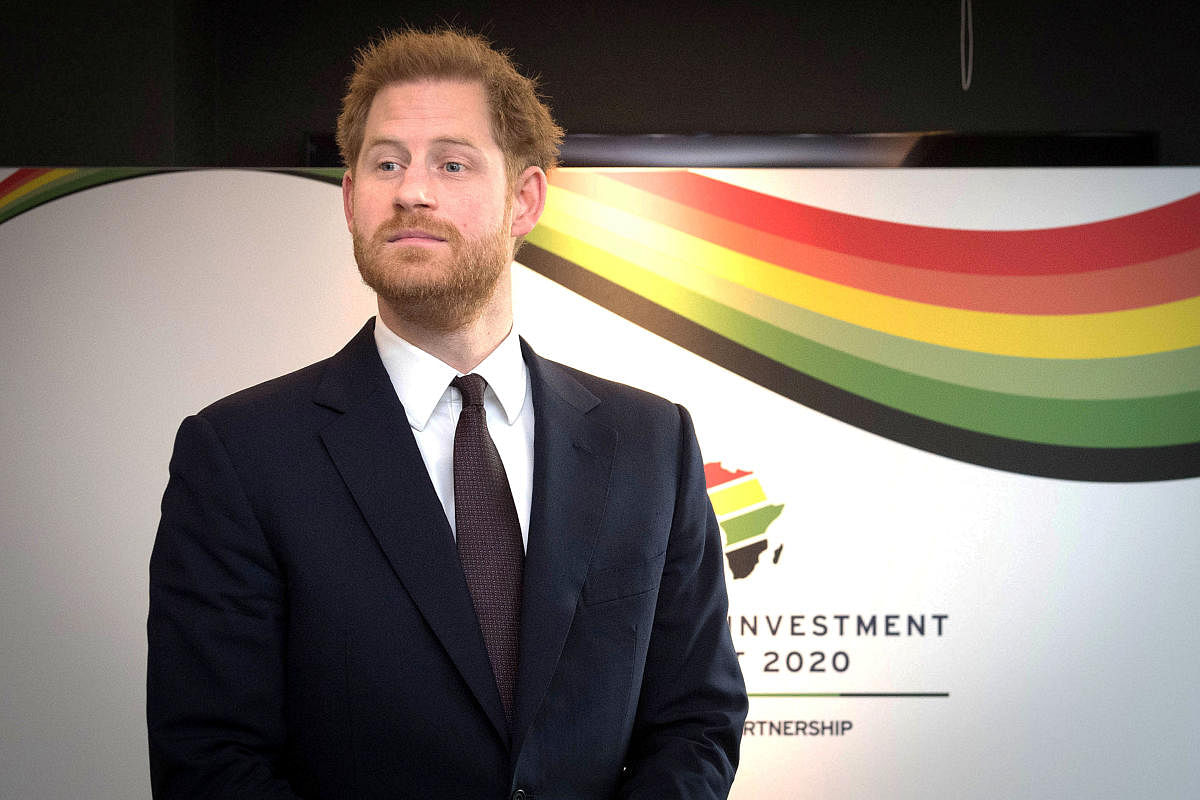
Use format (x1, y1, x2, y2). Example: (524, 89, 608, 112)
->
(529, 227, 1200, 447)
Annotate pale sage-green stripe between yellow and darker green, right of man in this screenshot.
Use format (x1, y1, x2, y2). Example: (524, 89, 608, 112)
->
(528, 209, 1200, 399)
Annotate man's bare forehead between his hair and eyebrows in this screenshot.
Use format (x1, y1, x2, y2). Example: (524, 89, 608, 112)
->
(366, 79, 497, 146)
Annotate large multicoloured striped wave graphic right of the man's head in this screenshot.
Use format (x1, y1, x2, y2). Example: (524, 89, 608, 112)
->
(521, 169, 1200, 481)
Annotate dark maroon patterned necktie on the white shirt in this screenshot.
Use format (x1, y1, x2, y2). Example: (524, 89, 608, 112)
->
(450, 373, 524, 721)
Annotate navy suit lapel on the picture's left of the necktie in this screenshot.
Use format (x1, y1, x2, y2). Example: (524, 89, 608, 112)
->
(316, 323, 508, 741)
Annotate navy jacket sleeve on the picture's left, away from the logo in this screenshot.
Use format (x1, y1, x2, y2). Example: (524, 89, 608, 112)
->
(146, 416, 296, 799)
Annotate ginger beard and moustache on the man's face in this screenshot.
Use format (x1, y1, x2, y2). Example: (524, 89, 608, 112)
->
(353, 206, 512, 332)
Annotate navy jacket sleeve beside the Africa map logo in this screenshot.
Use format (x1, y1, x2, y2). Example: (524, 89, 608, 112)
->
(620, 407, 748, 800)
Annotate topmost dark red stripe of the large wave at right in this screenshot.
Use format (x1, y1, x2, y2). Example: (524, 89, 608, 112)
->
(606, 170, 1200, 275)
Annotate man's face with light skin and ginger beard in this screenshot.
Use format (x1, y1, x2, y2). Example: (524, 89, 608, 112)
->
(342, 80, 518, 331)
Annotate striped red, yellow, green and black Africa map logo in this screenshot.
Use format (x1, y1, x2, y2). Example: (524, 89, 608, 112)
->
(704, 462, 784, 581)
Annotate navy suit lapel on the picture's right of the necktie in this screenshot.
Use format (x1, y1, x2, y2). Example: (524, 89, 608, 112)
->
(512, 342, 617, 754)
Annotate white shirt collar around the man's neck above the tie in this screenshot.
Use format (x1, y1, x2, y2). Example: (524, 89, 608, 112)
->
(374, 319, 529, 431)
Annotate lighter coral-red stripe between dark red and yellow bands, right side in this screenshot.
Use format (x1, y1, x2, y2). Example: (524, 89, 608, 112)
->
(554, 172, 1200, 314)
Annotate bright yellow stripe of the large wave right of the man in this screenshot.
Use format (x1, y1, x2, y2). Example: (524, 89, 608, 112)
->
(544, 186, 1200, 359)
